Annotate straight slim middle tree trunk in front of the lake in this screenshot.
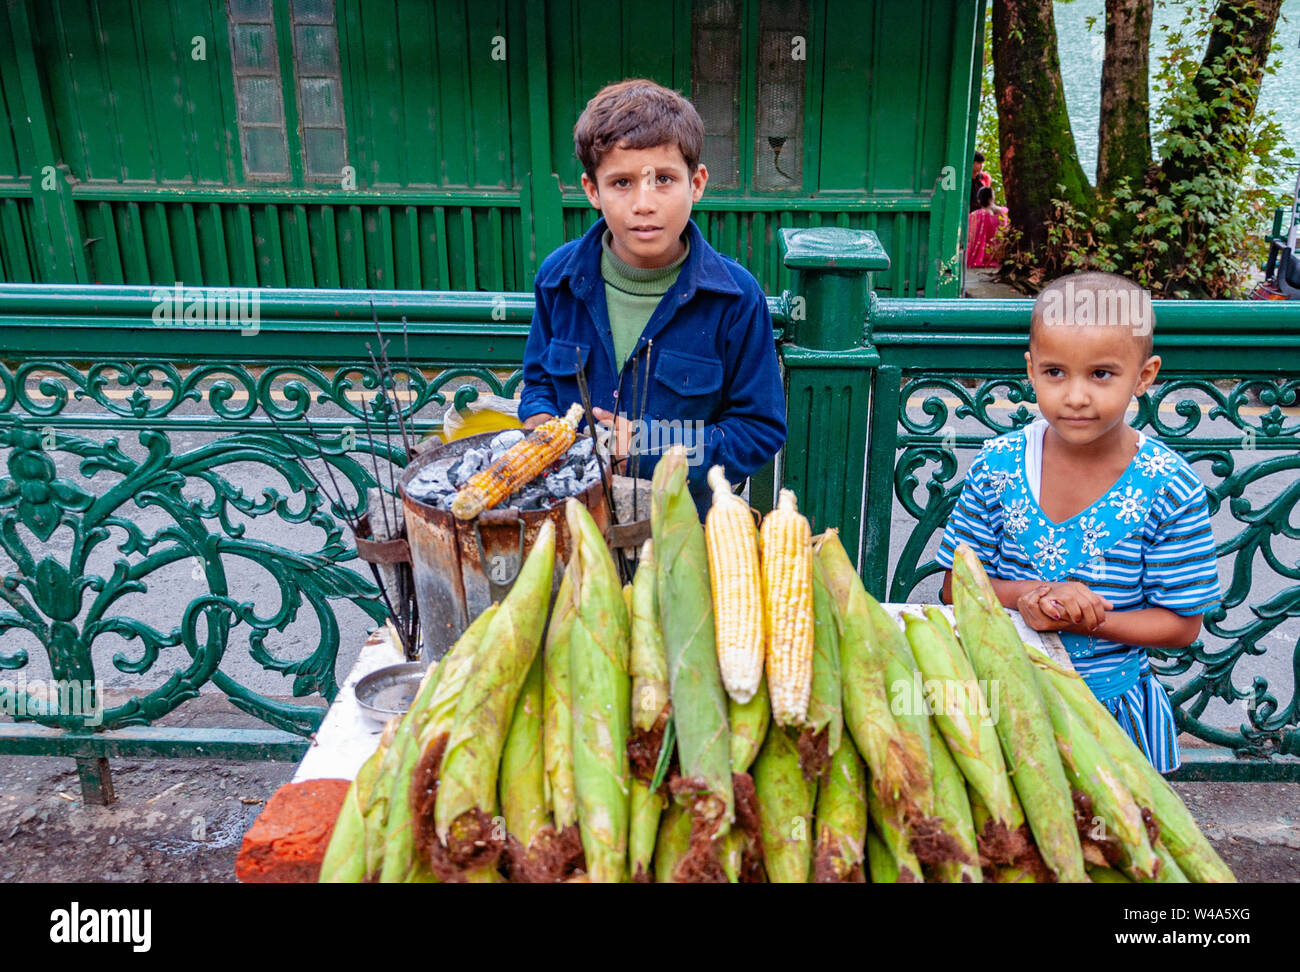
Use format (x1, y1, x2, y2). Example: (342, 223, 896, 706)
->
(1097, 0, 1154, 195)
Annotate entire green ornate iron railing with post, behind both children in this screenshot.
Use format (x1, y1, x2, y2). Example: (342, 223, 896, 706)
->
(0, 230, 1300, 778)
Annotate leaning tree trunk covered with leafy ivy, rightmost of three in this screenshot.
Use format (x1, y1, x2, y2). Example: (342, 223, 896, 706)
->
(1161, 0, 1282, 185)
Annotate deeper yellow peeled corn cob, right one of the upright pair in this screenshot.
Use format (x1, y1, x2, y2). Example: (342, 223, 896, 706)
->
(761, 490, 813, 725)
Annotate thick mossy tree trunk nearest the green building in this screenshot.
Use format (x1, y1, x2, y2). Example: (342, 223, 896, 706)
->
(993, 0, 1092, 251)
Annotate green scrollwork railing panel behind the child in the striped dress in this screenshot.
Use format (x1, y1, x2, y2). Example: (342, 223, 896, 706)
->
(894, 372, 1300, 756)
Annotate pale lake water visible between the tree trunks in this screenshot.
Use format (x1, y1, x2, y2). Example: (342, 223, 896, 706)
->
(1054, 0, 1300, 198)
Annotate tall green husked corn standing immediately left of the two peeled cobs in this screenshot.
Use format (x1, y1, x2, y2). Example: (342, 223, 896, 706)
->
(650, 446, 736, 839)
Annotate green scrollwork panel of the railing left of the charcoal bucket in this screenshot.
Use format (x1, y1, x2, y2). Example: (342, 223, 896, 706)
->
(0, 358, 521, 735)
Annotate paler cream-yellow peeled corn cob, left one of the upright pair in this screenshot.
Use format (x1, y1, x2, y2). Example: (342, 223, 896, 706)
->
(705, 465, 764, 706)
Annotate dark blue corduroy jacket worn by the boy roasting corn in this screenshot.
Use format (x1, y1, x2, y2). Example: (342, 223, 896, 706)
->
(519, 218, 785, 516)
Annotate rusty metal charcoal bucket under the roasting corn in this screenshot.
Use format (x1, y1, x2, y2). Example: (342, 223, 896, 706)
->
(398, 431, 610, 659)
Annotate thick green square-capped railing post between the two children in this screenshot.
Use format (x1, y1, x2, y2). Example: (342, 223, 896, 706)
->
(780, 227, 889, 560)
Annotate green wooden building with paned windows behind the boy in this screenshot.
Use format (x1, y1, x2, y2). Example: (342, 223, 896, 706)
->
(0, 0, 984, 296)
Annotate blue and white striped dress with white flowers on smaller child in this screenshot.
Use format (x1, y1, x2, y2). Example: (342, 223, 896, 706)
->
(936, 420, 1219, 773)
